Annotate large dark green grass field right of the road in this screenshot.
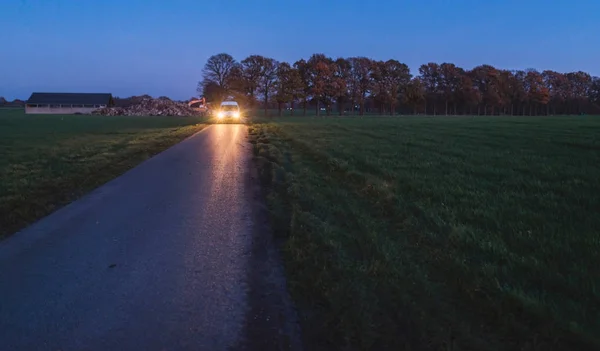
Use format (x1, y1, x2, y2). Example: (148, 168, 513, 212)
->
(251, 117, 600, 350)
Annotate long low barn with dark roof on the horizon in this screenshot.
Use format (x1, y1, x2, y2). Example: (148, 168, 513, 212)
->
(25, 93, 114, 115)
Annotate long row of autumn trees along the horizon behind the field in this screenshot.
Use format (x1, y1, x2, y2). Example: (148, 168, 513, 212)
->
(198, 53, 600, 115)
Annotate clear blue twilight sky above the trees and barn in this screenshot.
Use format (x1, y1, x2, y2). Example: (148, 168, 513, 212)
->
(0, 0, 600, 99)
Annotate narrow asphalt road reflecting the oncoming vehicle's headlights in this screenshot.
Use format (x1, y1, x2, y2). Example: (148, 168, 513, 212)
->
(0, 125, 296, 350)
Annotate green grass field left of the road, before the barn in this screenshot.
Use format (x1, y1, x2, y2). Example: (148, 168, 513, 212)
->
(0, 109, 204, 238)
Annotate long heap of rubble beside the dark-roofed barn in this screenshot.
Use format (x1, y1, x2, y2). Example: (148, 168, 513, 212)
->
(93, 97, 198, 116)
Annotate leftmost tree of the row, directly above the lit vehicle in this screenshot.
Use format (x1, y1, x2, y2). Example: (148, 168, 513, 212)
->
(198, 53, 238, 99)
